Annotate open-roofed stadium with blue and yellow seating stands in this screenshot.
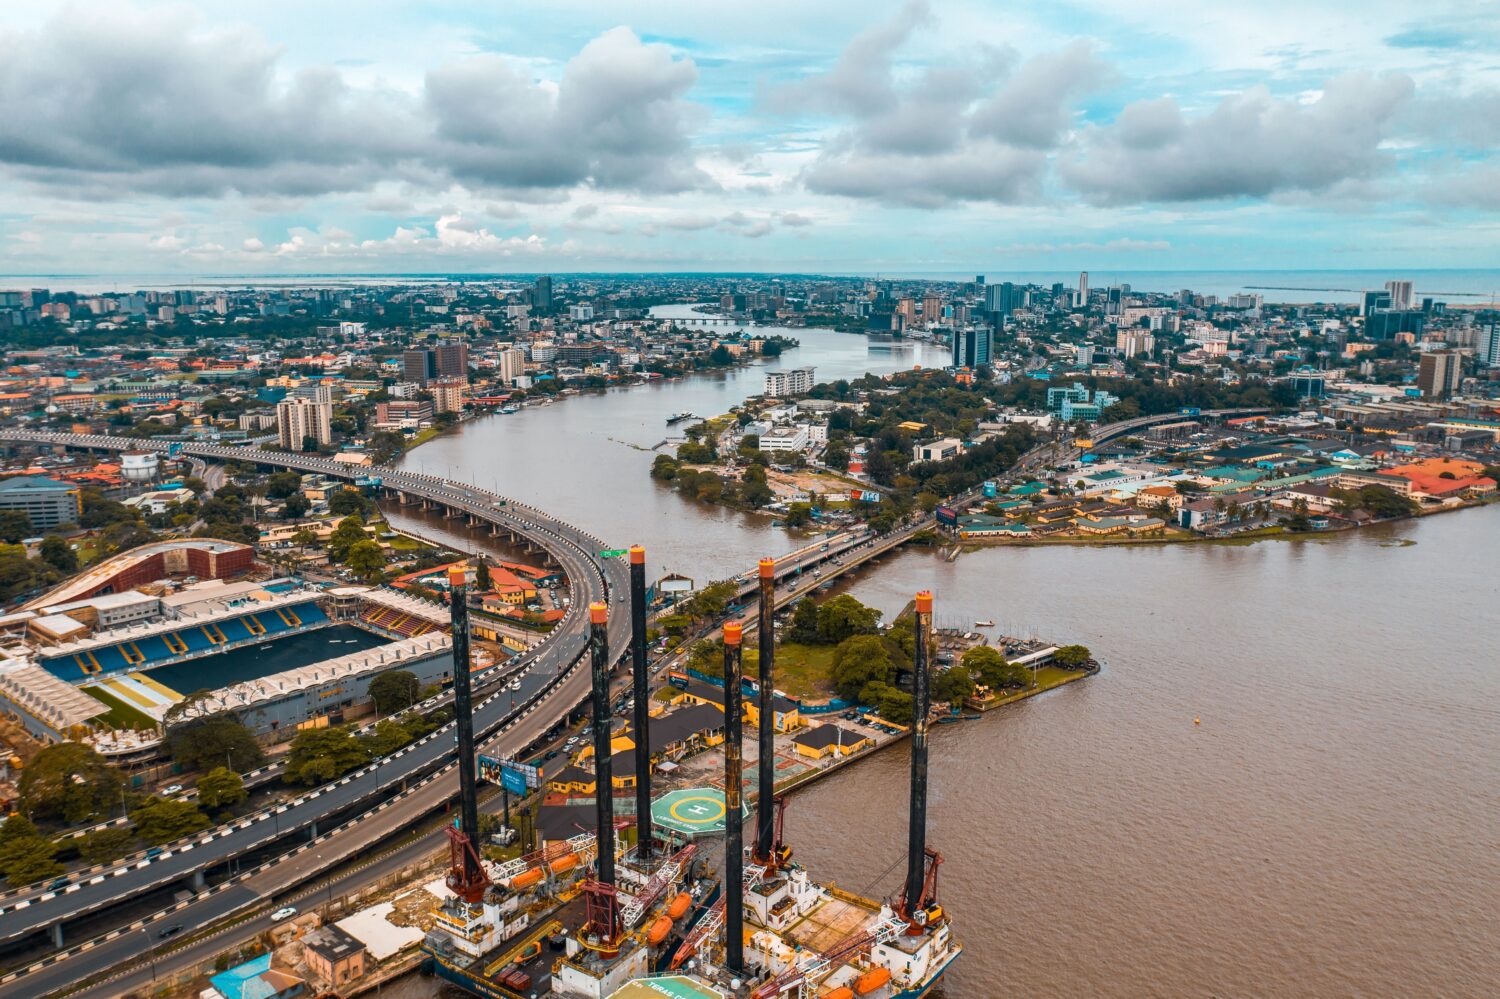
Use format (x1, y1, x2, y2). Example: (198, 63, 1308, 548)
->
(0, 539, 492, 758)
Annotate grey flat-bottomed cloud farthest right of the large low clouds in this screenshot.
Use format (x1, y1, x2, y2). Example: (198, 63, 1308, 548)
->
(1061, 74, 1415, 204)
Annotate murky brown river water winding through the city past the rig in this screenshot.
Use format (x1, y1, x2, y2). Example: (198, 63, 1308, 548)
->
(386, 307, 1500, 999)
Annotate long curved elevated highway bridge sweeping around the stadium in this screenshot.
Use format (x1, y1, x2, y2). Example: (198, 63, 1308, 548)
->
(0, 431, 630, 972)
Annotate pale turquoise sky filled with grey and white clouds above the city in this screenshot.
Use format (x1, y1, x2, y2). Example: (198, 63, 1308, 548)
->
(0, 0, 1500, 276)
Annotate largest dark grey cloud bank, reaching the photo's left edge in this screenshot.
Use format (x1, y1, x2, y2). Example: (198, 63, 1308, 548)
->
(0, 8, 708, 201)
